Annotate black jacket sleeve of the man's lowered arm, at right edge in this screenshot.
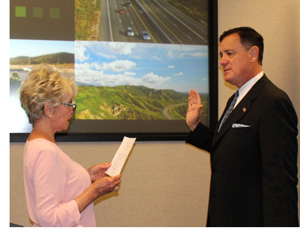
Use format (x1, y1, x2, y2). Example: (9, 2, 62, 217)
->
(259, 92, 298, 226)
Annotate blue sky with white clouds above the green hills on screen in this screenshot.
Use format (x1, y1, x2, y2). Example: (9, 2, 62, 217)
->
(75, 41, 208, 93)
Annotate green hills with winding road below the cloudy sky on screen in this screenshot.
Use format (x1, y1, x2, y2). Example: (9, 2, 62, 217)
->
(75, 86, 207, 120)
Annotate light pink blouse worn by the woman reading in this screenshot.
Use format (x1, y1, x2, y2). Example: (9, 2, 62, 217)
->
(23, 138, 96, 227)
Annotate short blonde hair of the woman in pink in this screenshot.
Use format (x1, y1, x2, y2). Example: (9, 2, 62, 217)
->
(20, 65, 78, 124)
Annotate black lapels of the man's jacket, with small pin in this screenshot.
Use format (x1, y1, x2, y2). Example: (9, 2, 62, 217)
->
(213, 75, 269, 146)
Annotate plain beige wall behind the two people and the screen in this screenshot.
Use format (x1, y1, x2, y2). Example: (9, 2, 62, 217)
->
(9, 0, 300, 227)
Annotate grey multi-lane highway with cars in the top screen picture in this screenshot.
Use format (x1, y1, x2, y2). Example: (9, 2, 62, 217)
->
(100, 0, 208, 45)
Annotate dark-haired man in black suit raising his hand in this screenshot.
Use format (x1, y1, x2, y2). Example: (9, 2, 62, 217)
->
(186, 27, 299, 227)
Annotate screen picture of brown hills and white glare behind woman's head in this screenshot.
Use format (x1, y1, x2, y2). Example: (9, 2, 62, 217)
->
(9, 39, 74, 133)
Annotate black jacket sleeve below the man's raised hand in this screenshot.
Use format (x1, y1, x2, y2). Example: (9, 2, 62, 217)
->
(186, 123, 213, 152)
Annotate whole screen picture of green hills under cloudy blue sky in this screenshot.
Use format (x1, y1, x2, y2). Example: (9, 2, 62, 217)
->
(75, 41, 208, 120)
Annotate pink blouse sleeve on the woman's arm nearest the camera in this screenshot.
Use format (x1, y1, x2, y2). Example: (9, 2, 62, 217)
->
(33, 147, 80, 227)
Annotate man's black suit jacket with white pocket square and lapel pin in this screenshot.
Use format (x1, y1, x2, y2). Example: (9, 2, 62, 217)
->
(187, 75, 299, 226)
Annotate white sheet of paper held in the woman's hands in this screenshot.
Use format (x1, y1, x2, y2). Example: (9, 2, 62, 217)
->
(105, 137, 136, 176)
